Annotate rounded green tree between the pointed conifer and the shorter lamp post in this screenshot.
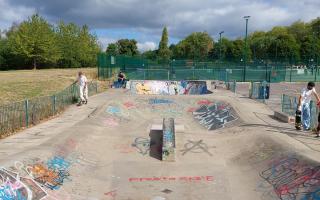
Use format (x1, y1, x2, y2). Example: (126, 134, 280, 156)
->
(175, 32, 213, 60)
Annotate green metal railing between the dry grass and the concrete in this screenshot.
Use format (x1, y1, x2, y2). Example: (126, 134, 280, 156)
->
(0, 82, 98, 137)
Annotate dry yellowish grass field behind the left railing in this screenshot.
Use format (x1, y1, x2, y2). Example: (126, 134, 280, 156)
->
(0, 68, 97, 105)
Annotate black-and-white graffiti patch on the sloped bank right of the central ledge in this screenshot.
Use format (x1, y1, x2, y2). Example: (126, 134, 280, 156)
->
(193, 103, 237, 130)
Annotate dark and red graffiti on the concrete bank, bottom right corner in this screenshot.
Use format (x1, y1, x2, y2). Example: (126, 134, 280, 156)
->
(260, 157, 320, 200)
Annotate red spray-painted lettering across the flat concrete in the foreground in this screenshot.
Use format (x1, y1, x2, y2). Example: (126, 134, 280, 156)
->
(129, 176, 213, 182)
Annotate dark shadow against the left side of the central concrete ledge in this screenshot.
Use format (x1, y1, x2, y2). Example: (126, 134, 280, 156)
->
(149, 130, 163, 160)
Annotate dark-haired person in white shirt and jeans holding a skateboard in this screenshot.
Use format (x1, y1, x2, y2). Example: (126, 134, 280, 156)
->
(298, 82, 320, 130)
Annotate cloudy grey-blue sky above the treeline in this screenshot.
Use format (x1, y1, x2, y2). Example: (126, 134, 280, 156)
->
(0, 0, 320, 50)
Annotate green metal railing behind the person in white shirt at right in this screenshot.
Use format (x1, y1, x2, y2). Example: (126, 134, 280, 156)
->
(281, 94, 319, 128)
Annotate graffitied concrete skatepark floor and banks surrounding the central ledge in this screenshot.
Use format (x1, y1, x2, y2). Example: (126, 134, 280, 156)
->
(0, 89, 320, 200)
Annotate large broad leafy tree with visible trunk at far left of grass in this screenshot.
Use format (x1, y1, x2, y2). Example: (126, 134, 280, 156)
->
(9, 14, 60, 69)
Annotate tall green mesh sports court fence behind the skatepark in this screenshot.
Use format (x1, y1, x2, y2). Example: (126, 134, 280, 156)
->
(98, 53, 320, 82)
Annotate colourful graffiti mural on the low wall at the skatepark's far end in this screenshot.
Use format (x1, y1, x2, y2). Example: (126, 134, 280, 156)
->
(130, 81, 208, 95)
